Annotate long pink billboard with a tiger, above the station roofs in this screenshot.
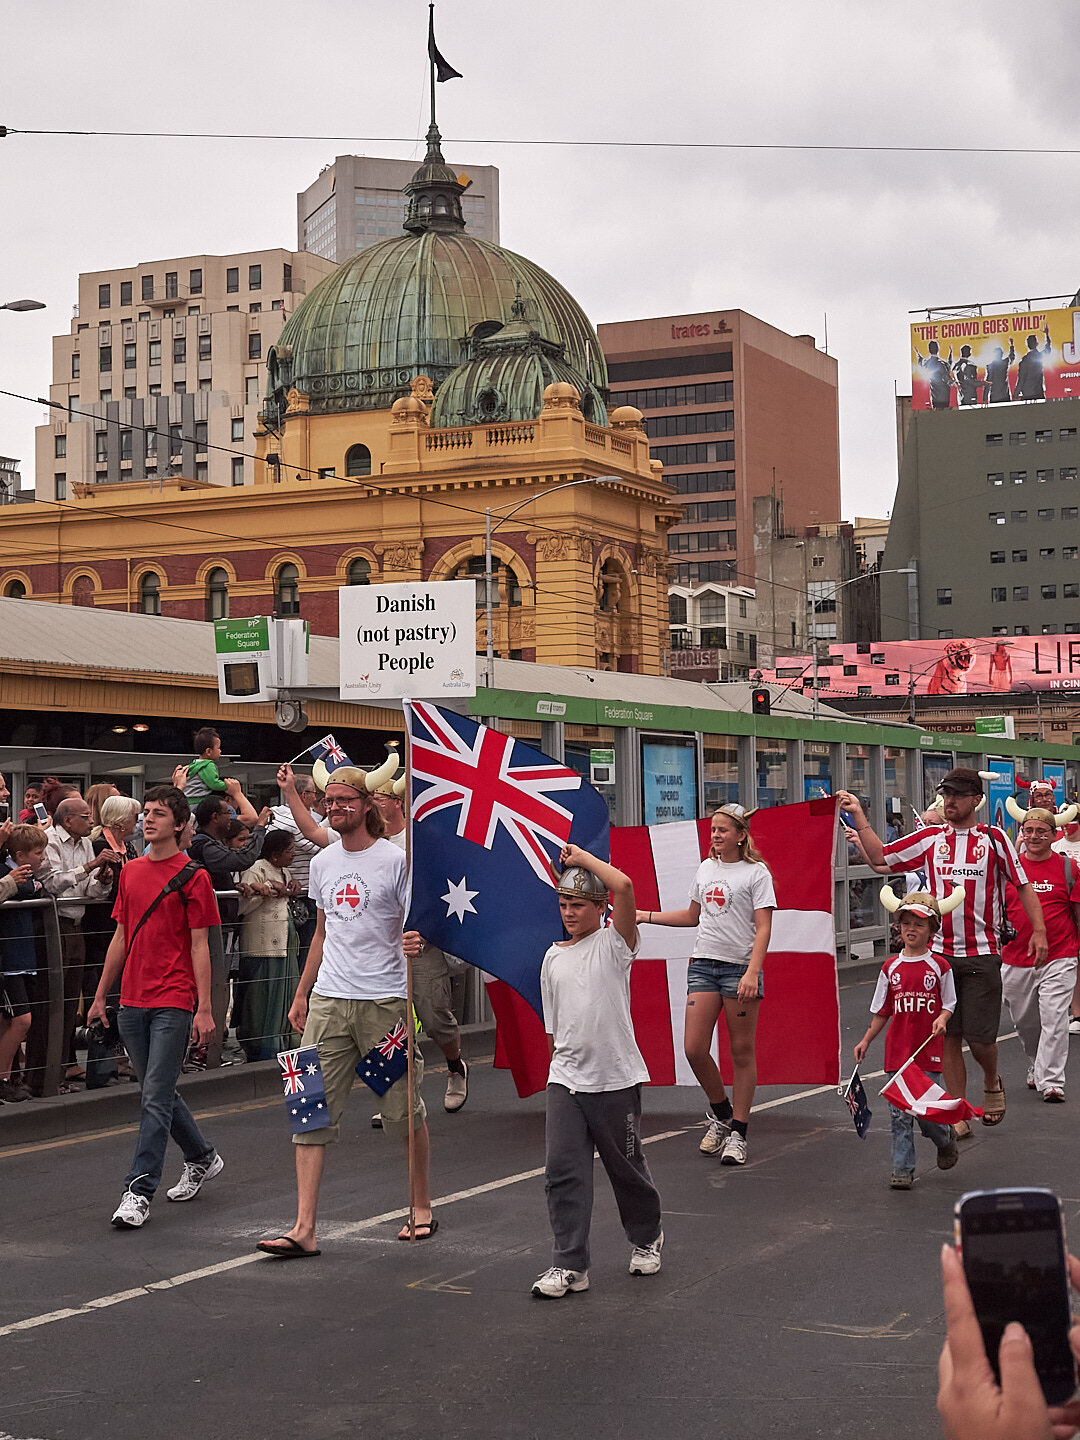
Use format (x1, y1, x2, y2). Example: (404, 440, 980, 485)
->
(762, 635, 1080, 698)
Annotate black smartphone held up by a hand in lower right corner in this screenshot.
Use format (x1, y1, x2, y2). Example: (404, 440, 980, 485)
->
(953, 1189, 1076, 1405)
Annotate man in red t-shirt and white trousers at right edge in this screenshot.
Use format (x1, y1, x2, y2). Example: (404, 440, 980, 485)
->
(1001, 812, 1080, 1104)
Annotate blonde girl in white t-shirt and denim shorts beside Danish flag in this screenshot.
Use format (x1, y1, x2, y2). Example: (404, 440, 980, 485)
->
(638, 805, 776, 1165)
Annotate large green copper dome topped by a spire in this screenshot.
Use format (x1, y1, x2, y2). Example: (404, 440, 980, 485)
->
(265, 131, 608, 423)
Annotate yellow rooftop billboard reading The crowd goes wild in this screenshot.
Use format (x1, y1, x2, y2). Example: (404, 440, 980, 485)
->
(912, 310, 1080, 410)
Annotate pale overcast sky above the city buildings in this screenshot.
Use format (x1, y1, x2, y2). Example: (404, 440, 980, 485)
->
(0, 0, 1080, 518)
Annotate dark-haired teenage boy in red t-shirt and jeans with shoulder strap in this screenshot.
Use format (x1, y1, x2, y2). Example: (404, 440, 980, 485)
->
(86, 785, 225, 1230)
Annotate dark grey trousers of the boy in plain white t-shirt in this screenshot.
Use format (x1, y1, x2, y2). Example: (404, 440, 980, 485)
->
(544, 1084, 660, 1270)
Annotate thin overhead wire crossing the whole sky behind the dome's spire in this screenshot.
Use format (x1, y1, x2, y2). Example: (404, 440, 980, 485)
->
(0, 125, 1080, 156)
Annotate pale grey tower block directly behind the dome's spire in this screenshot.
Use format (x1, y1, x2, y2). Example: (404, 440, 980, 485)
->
(297, 156, 498, 265)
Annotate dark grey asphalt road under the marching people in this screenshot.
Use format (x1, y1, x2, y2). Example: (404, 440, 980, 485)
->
(0, 984, 1080, 1440)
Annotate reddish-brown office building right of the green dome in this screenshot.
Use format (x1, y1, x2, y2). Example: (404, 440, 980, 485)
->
(598, 310, 840, 586)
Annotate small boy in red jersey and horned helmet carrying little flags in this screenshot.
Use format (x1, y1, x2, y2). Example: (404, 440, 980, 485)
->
(855, 893, 959, 1189)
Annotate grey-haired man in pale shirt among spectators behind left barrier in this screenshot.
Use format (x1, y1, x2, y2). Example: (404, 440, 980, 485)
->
(42, 795, 124, 1080)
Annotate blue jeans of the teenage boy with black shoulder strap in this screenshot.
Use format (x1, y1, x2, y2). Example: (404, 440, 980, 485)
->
(117, 1005, 213, 1200)
